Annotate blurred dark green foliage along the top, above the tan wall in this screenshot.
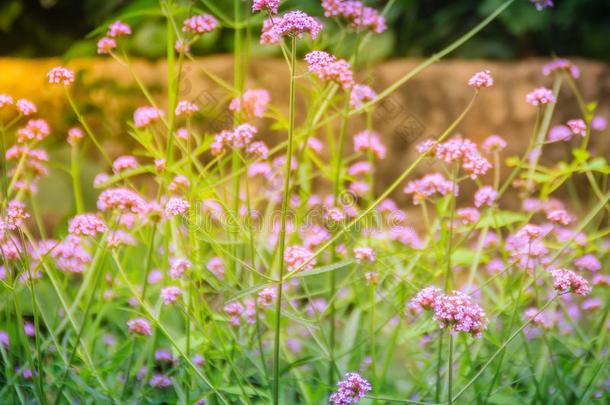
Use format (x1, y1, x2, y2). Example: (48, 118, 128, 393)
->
(0, 0, 610, 60)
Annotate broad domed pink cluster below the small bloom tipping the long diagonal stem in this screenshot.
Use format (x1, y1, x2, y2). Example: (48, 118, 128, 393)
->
(436, 136, 491, 179)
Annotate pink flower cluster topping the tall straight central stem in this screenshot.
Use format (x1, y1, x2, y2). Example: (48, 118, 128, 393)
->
(261, 10, 322, 45)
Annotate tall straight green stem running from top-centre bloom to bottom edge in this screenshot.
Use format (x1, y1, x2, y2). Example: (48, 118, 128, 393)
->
(273, 37, 297, 405)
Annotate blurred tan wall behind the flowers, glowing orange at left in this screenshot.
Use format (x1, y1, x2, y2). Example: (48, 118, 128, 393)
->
(0, 56, 610, 208)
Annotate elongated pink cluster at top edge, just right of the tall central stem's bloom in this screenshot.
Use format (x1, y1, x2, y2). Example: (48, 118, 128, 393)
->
(322, 0, 387, 34)
